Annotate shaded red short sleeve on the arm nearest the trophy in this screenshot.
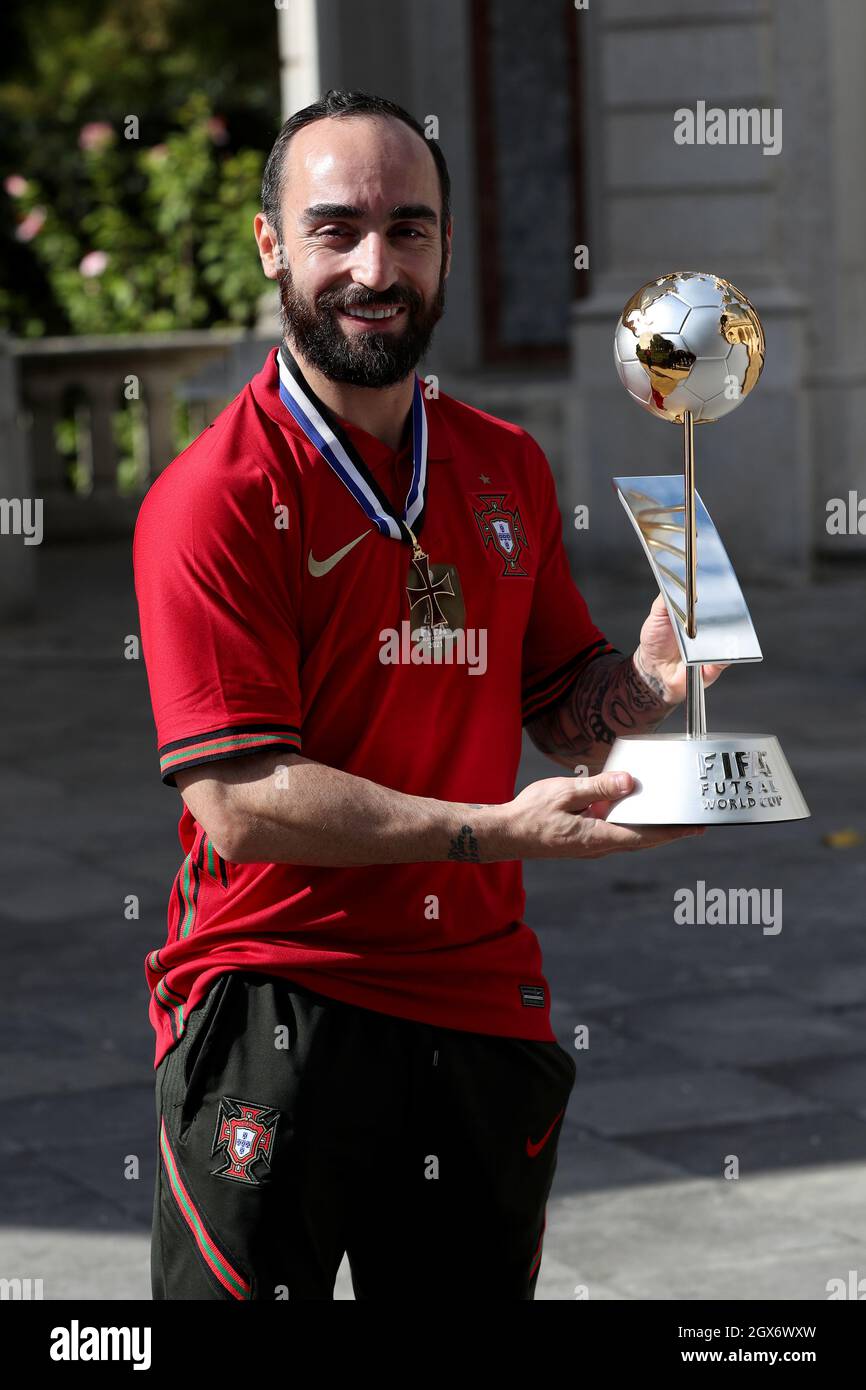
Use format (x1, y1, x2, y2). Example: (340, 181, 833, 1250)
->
(521, 435, 621, 724)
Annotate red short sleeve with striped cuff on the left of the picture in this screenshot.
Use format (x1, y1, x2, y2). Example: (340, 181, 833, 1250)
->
(132, 456, 302, 787)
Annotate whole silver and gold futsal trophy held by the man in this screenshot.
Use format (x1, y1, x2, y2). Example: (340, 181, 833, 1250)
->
(605, 271, 809, 826)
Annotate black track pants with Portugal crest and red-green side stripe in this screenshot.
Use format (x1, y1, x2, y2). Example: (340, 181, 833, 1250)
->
(152, 972, 577, 1301)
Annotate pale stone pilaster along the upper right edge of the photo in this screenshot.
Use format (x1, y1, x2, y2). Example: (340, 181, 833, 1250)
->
(778, 0, 866, 557)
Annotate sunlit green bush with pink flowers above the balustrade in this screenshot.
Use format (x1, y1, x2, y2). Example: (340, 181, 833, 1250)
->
(7, 93, 264, 334)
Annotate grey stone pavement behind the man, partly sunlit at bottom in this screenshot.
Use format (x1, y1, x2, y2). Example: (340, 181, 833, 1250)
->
(0, 543, 866, 1300)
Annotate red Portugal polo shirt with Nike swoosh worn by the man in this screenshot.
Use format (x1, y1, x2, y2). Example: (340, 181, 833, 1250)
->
(133, 350, 613, 1065)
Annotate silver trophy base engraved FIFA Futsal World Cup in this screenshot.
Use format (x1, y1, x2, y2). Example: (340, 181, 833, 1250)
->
(603, 734, 810, 826)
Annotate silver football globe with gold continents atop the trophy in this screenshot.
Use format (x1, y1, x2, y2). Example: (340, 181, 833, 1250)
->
(613, 270, 765, 424)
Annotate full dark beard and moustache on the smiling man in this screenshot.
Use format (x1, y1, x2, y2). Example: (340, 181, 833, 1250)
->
(277, 259, 445, 388)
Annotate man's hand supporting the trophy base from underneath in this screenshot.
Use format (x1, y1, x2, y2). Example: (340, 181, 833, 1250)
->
(497, 773, 703, 859)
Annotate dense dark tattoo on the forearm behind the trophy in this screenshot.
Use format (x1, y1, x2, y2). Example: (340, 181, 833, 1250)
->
(527, 653, 674, 769)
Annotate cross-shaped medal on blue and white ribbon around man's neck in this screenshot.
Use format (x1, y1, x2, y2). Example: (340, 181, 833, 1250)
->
(277, 343, 466, 636)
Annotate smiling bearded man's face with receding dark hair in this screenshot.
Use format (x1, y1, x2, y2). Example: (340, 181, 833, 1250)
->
(256, 117, 450, 386)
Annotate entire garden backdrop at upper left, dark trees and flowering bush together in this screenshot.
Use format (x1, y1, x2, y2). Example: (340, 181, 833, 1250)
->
(0, 0, 279, 336)
